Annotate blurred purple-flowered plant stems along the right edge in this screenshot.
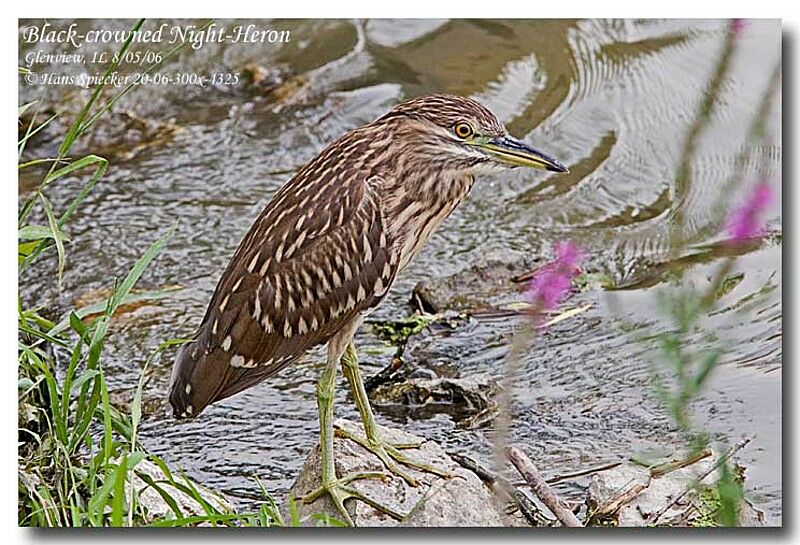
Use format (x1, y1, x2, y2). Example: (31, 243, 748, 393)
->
(650, 19, 780, 526)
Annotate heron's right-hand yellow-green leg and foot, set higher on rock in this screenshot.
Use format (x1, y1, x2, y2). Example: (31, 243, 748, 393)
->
(336, 342, 450, 486)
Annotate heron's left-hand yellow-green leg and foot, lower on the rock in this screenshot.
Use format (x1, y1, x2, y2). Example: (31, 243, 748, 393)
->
(303, 346, 410, 526)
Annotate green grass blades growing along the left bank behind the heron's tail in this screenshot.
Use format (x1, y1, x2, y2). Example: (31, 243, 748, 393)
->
(18, 21, 297, 527)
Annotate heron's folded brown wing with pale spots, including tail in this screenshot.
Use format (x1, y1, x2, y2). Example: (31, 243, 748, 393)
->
(170, 170, 398, 416)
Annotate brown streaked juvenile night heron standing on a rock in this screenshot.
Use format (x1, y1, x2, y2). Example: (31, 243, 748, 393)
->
(170, 95, 567, 524)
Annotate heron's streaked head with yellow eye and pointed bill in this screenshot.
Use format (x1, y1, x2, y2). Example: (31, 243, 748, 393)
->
(378, 95, 568, 174)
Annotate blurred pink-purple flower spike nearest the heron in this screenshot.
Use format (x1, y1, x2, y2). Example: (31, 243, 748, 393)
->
(526, 241, 583, 313)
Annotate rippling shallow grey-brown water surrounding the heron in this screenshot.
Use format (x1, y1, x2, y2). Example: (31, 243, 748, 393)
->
(21, 20, 782, 522)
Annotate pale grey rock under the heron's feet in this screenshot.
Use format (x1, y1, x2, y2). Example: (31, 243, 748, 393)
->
(283, 420, 506, 527)
